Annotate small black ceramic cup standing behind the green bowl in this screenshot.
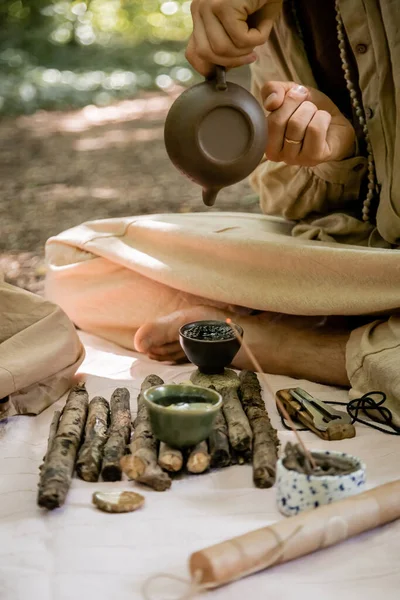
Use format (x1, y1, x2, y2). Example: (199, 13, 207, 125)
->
(179, 320, 243, 375)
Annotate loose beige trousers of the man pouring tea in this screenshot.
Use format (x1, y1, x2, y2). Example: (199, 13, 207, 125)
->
(46, 212, 400, 420)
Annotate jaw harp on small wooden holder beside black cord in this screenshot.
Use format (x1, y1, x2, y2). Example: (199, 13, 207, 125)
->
(277, 388, 356, 440)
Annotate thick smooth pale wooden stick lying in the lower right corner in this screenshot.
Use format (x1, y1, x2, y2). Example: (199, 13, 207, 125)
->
(189, 479, 400, 589)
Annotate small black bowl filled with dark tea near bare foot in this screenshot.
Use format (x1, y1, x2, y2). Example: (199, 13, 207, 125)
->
(179, 320, 243, 374)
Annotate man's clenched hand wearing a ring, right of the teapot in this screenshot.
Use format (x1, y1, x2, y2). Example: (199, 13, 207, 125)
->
(262, 81, 356, 167)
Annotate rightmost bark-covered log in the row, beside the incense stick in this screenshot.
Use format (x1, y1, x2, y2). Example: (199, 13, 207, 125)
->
(239, 371, 279, 488)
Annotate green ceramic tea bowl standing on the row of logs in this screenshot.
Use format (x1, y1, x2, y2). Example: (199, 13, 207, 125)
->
(143, 384, 222, 448)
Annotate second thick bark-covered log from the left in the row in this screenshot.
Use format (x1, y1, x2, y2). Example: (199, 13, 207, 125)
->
(76, 396, 110, 481)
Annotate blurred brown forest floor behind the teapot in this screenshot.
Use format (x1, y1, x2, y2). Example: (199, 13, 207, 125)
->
(0, 65, 259, 294)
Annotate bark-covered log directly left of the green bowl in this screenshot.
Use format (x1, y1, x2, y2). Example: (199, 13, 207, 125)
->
(121, 375, 171, 492)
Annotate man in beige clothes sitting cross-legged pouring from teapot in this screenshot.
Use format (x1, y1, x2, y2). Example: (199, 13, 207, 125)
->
(47, 0, 400, 420)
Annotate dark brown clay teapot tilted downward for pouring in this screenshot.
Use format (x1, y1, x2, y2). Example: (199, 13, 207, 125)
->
(164, 66, 267, 206)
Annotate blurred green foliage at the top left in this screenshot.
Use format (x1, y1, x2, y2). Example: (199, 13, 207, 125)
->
(0, 0, 195, 114)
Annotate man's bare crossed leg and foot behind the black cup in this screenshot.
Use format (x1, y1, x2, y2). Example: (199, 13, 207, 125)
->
(134, 305, 350, 386)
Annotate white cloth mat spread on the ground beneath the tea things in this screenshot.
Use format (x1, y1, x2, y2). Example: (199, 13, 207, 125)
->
(0, 333, 400, 600)
